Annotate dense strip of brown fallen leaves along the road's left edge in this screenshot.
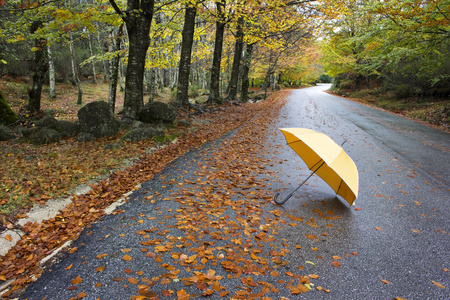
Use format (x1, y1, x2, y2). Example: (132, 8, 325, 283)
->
(0, 93, 288, 297)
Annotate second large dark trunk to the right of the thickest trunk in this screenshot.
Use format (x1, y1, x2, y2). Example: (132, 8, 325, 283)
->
(208, 0, 226, 103)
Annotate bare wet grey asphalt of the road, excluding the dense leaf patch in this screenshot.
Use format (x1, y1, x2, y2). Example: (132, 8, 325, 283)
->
(21, 86, 450, 300)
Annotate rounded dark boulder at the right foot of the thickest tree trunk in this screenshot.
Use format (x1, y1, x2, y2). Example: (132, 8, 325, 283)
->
(137, 101, 177, 124)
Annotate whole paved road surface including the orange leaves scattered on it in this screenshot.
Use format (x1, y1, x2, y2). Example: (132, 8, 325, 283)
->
(21, 86, 450, 300)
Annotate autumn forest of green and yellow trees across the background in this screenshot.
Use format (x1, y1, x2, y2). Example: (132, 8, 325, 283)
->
(0, 0, 450, 127)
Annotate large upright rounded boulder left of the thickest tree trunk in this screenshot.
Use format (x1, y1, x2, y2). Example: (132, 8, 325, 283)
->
(78, 101, 119, 138)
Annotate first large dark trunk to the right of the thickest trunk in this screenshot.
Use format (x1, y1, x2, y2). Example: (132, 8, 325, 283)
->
(175, 6, 197, 106)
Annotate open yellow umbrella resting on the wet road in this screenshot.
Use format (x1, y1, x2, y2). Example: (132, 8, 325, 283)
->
(274, 128, 359, 205)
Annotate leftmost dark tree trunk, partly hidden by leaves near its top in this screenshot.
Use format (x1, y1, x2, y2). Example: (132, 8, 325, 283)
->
(28, 21, 48, 113)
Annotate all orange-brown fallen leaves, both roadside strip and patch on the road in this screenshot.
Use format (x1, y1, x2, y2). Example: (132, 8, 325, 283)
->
(0, 92, 358, 299)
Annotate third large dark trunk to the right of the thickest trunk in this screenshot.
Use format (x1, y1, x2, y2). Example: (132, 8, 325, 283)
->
(227, 17, 244, 101)
